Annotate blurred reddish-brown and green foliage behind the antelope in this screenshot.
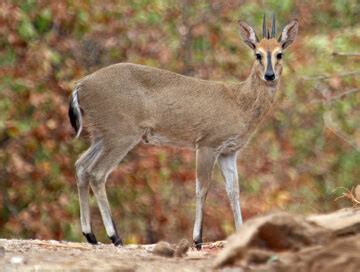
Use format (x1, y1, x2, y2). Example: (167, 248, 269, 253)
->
(0, 0, 360, 243)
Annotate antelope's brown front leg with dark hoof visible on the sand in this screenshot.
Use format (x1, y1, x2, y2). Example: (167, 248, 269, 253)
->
(193, 147, 216, 250)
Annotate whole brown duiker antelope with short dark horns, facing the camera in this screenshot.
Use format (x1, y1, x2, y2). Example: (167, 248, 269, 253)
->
(69, 16, 298, 249)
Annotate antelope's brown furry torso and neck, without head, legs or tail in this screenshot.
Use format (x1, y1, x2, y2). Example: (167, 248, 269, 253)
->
(78, 60, 277, 152)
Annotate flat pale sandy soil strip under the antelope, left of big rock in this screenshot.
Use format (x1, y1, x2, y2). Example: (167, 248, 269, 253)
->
(0, 239, 220, 271)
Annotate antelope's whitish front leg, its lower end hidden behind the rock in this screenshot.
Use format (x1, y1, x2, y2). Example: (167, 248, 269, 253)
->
(218, 153, 242, 231)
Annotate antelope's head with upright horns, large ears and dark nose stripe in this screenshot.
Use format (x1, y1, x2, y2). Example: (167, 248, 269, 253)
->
(239, 15, 299, 85)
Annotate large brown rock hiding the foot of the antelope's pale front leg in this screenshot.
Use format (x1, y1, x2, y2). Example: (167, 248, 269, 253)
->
(214, 212, 332, 268)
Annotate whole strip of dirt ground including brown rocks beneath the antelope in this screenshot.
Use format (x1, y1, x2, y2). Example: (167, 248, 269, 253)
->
(0, 209, 360, 272)
